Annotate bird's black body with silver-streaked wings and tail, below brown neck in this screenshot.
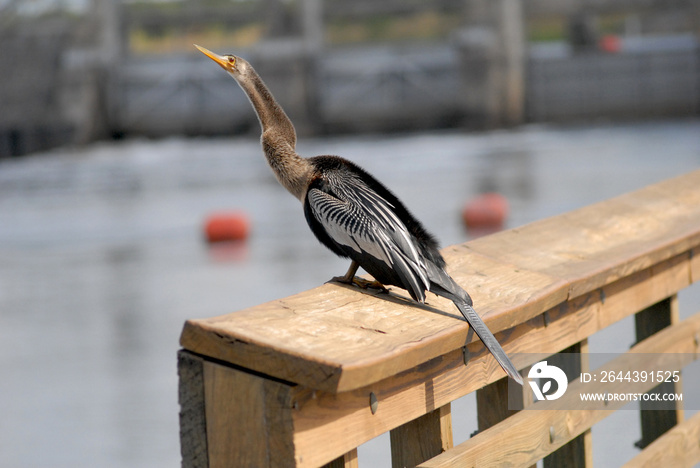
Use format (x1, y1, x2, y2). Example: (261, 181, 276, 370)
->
(304, 157, 522, 384)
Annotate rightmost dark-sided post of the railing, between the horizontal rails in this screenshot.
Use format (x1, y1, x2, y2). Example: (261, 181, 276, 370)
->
(634, 294, 683, 449)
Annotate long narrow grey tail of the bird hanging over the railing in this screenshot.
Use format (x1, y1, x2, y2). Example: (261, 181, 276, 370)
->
(430, 268, 523, 385)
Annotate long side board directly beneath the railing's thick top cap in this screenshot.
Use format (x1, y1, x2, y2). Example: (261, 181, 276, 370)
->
(286, 256, 689, 465)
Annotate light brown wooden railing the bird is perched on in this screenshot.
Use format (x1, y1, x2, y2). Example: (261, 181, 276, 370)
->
(179, 171, 700, 467)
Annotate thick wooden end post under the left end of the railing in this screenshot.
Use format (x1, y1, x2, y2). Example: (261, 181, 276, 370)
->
(178, 351, 294, 468)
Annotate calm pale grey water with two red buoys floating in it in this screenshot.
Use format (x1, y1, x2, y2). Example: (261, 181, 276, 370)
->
(0, 120, 700, 468)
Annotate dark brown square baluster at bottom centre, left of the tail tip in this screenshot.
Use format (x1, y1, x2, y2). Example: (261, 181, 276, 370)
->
(389, 404, 453, 468)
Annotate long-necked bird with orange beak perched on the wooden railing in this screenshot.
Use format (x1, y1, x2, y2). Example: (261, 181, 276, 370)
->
(195, 44, 523, 385)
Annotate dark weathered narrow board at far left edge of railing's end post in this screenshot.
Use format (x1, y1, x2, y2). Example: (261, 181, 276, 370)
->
(177, 350, 209, 468)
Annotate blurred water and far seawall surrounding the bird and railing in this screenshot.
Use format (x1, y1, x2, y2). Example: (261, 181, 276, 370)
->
(0, 0, 700, 467)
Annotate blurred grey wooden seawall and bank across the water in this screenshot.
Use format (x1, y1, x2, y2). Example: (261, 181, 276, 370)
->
(0, 0, 700, 151)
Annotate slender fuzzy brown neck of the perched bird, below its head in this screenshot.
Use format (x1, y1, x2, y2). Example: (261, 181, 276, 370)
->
(237, 67, 312, 200)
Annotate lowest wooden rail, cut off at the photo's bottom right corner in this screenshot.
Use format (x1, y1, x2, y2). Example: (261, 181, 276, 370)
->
(624, 413, 700, 468)
